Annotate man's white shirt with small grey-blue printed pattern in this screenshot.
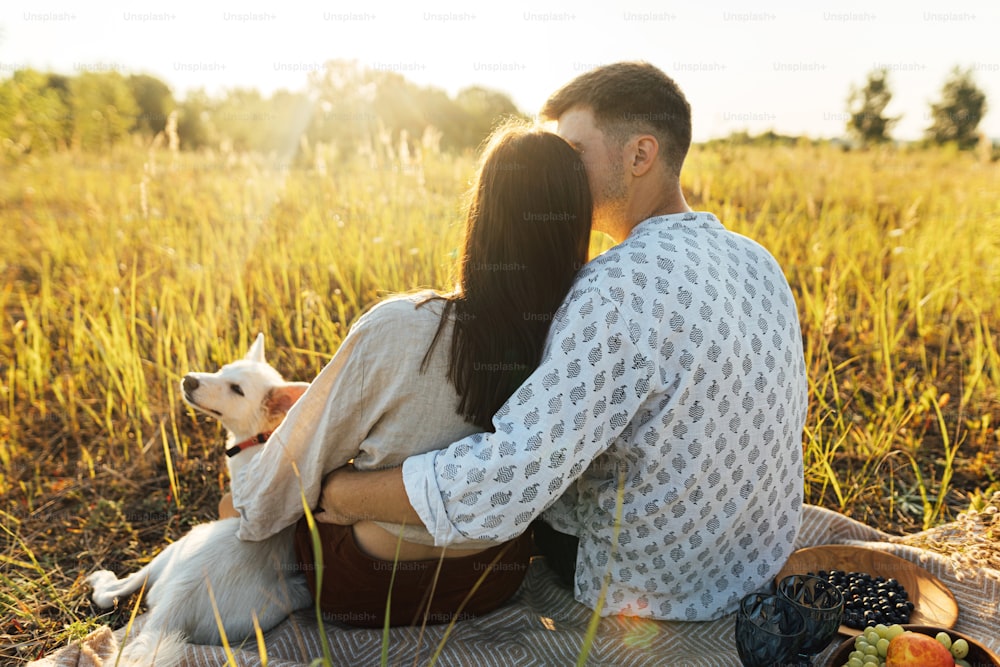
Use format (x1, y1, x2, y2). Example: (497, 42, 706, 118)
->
(403, 213, 807, 621)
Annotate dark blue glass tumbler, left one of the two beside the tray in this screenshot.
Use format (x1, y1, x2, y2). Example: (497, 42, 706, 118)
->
(736, 593, 806, 667)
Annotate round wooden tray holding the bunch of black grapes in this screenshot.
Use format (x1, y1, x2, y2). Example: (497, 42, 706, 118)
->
(775, 545, 958, 636)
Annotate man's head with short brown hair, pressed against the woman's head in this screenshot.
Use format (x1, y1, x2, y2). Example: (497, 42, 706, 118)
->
(541, 62, 691, 237)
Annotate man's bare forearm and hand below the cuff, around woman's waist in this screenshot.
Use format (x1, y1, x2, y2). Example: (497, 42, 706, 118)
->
(315, 465, 422, 526)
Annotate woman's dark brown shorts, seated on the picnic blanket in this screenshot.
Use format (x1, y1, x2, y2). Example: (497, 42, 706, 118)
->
(295, 519, 532, 628)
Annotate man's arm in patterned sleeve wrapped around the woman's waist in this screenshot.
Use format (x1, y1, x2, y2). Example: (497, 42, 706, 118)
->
(323, 289, 657, 546)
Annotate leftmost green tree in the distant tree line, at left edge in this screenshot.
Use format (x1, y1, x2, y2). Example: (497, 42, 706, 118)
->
(0, 69, 68, 154)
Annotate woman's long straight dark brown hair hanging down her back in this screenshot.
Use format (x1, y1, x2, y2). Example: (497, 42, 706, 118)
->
(425, 124, 591, 431)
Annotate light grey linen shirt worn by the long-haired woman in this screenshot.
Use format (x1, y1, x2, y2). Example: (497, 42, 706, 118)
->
(232, 292, 484, 549)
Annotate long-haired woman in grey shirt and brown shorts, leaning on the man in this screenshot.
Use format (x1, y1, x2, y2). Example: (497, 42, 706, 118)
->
(227, 125, 591, 627)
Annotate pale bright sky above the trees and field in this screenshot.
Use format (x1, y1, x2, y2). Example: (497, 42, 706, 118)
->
(0, 0, 1000, 141)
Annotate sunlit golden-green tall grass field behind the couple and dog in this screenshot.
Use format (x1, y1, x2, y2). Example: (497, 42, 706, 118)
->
(0, 145, 1000, 664)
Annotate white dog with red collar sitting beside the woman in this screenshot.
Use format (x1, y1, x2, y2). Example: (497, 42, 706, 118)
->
(87, 334, 312, 665)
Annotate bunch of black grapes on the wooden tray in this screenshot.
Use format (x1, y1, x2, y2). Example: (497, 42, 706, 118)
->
(809, 570, 913, 630)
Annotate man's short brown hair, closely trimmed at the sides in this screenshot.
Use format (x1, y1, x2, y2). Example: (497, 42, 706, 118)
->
(541, 62, 691, 176)
